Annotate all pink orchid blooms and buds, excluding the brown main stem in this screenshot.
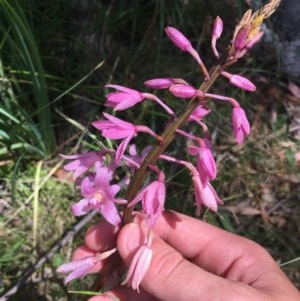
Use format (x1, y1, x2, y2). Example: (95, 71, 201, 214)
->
(58, 17, 255, 290)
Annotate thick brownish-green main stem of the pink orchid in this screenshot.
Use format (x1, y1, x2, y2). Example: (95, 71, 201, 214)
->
(123, 63, 224, 224)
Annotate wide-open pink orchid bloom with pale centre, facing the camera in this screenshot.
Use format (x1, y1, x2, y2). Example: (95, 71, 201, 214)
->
(71, 163, 126, 225)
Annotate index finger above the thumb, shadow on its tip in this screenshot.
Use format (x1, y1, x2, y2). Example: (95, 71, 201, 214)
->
(154, 211, 280, 283)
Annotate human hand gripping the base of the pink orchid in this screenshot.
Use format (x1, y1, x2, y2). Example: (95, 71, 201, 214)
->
(74, 212, 300, 301)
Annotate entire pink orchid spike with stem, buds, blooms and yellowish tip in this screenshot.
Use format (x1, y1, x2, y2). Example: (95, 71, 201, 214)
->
(57, 0, 279, 290)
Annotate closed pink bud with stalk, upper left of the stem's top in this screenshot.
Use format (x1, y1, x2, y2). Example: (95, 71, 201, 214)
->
(165, 26, 209, 80)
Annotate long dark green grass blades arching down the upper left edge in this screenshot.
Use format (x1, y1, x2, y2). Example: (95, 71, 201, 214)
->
(0, 0, 55, 154)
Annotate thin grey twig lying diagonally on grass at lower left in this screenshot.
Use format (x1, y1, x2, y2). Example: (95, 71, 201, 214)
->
(0, 211, 97, 301)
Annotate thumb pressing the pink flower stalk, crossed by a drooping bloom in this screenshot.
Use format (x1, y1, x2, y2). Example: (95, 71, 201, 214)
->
(117, 223, 245, 301)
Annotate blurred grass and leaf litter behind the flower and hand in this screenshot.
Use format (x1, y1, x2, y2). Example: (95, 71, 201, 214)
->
(0, 0, 300, 300)
